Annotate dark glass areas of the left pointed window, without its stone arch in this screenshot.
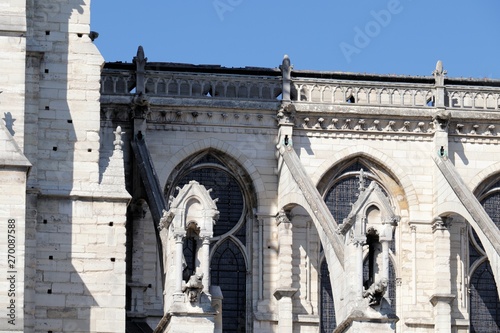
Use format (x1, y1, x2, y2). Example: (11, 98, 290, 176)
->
(174, 154, 247, 333)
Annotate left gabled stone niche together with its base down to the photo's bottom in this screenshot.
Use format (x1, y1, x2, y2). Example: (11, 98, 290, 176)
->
(155, 180, 222, 333)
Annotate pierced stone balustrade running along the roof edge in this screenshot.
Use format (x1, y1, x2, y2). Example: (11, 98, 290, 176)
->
(101, 69, 500, 111)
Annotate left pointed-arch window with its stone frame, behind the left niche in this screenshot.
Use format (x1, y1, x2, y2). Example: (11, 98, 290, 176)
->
(166, 151, 255, 333)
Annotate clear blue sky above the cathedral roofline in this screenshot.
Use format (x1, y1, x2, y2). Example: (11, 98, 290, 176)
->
(91, 0, 500, 79)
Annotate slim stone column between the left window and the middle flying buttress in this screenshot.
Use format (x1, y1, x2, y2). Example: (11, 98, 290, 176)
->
(274, 210, 297, 333)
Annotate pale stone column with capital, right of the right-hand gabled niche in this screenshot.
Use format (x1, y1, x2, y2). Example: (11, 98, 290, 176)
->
(430, 217, 455, 333)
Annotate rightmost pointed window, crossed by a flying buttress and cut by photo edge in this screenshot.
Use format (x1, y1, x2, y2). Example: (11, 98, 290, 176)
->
(469, 177, 500, 333)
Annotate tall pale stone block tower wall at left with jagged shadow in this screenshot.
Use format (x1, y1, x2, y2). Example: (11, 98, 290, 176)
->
(21, 0, 129, 332)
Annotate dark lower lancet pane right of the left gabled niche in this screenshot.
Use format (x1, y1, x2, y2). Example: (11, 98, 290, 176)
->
(210, 239, 246, 333)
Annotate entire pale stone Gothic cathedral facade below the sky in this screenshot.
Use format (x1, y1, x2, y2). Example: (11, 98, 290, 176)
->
(0, 0, 500, 333)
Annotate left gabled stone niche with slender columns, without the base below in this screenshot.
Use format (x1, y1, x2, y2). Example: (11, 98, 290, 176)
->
(160, 180, 219, 306)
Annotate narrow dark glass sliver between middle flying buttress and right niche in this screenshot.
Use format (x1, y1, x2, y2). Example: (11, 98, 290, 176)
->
(320, 259, 337, 333)
